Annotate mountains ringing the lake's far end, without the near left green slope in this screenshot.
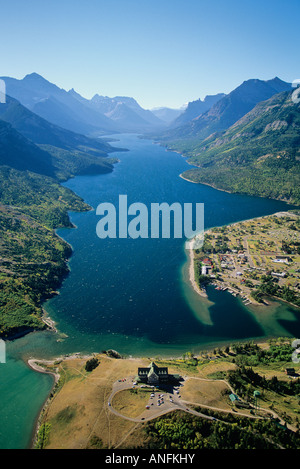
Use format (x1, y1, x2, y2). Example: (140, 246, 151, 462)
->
(0, 73, 299, 201)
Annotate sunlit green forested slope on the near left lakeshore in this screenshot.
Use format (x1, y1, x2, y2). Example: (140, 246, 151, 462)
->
(0, 165, 90, 337)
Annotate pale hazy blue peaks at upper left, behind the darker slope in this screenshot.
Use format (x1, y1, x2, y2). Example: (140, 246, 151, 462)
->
(1, 73, 165, 137)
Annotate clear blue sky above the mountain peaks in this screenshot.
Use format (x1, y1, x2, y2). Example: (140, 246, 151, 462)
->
(0, 0, 300, 109)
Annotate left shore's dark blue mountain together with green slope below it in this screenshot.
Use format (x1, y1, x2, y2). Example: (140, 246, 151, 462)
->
(0, 88, 118, 337)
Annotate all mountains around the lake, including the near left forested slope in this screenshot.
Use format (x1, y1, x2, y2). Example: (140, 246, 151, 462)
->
(0, 73, 300, 336)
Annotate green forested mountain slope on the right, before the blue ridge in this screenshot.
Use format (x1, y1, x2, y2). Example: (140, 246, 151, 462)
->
(183, 92, 300, 203)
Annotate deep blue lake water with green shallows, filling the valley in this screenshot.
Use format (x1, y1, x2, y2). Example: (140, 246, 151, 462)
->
(0, 135, 300, 448)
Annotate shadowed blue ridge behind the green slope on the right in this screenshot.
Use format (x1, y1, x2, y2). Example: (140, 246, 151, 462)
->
(161, 77, 291, 141)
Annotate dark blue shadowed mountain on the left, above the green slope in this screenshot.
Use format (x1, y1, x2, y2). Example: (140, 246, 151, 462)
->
(0, 91, 126, 185)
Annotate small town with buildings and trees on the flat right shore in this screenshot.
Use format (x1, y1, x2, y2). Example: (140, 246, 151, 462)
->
(194, 212, 300, 306)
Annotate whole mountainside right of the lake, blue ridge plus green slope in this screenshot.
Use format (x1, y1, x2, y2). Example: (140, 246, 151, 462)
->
(153, 77, 300, 204)
